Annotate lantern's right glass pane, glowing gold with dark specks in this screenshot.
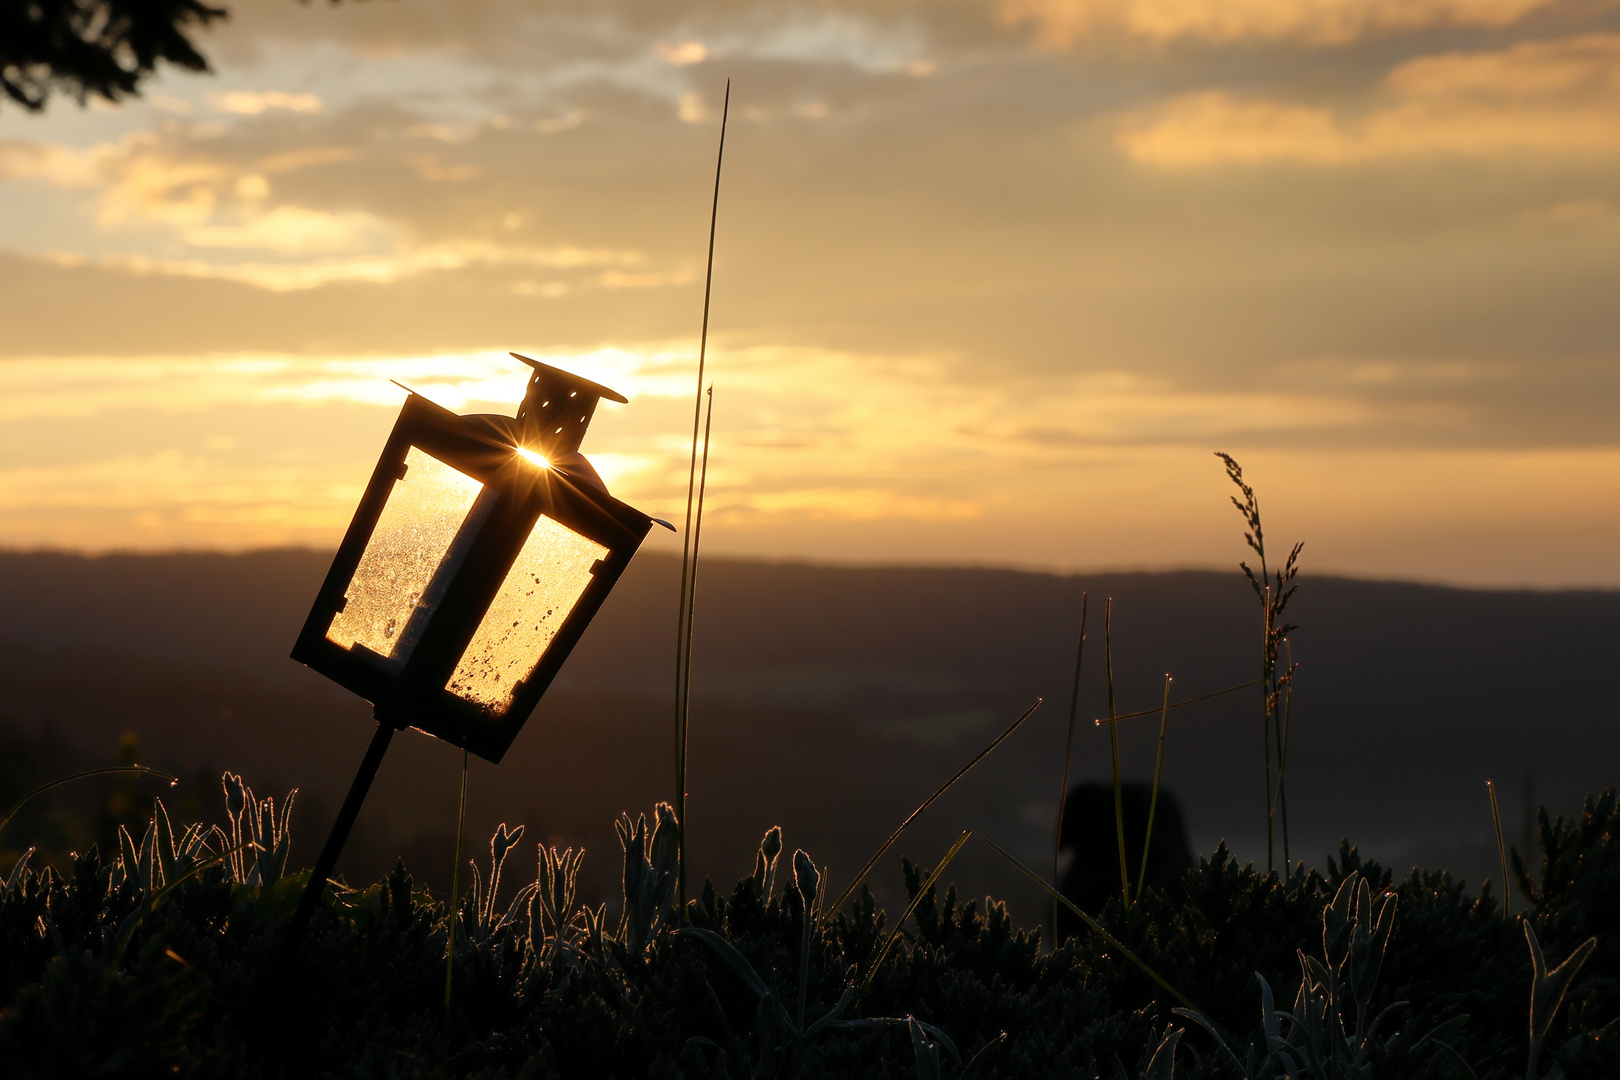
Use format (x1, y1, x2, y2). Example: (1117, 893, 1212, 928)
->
(446, 517, 608, 714)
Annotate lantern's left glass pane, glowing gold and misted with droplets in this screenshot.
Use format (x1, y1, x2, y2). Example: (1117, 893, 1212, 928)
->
(326, 447, 489, 665)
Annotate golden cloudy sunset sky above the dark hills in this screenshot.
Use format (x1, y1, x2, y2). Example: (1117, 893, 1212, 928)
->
(0, 0, 1620, 586)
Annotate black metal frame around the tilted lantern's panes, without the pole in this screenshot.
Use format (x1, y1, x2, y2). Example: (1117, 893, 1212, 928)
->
(292, 383, 653, 764)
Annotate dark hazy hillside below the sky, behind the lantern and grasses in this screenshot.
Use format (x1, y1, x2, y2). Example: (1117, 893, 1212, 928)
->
(0, 551, 1620, 921)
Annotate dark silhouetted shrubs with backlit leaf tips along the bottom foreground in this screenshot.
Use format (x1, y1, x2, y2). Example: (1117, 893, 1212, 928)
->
(0, 777, 1620, 1080)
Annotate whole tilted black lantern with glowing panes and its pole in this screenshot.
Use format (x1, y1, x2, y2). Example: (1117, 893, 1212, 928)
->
(288, 353, 660, 946)
